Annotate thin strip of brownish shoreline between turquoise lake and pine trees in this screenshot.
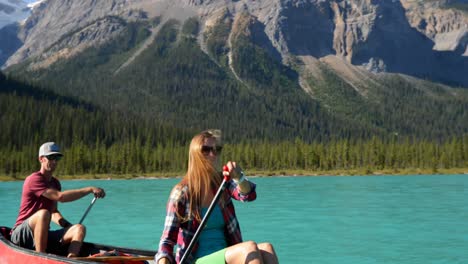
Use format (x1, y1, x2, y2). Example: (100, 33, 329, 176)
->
(0, 168, 468, 182)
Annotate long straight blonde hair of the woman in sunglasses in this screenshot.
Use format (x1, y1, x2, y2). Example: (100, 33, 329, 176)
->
(176, 130, 222, 222)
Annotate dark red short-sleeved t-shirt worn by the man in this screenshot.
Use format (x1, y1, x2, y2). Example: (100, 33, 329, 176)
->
(14, 171, 62, 227)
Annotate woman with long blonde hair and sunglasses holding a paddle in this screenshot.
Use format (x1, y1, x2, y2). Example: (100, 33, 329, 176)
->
(155, 130, 278, 264)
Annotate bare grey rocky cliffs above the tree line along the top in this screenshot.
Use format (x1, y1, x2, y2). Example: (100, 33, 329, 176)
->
(4, 0, 468, 87)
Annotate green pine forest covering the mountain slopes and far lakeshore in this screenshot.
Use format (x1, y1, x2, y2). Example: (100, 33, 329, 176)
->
(0, 17, 468, 179)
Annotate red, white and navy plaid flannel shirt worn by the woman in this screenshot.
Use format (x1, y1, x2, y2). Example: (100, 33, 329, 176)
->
(155, 177, 257, 263)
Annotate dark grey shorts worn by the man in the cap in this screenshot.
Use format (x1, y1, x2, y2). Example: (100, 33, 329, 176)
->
(11, 219, 65, 254)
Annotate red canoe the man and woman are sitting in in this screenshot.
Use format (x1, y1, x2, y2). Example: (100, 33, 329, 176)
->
(0, 226, 156, 264)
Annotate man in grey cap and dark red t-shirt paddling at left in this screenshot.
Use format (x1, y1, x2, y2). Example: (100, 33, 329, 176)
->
(11, 142, 106, 257)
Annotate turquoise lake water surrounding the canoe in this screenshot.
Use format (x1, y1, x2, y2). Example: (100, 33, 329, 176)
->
(0, 175, 468, 264)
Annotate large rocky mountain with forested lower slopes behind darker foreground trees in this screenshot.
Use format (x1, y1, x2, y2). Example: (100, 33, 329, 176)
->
(3, 0, 468, 139)
